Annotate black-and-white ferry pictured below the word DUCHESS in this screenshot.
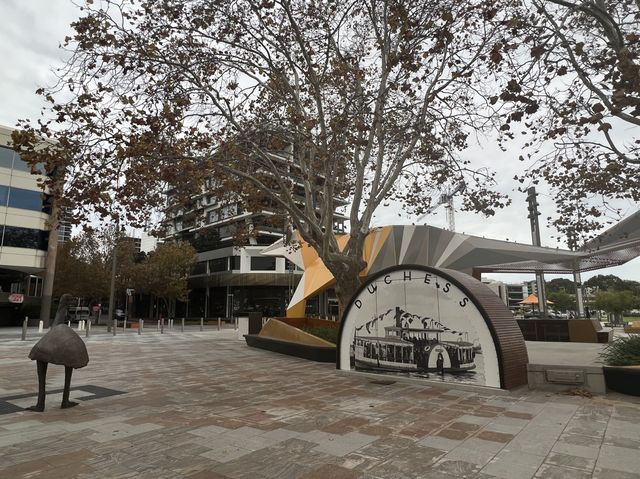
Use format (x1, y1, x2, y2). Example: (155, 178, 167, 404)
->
(352, 307, 480, 374)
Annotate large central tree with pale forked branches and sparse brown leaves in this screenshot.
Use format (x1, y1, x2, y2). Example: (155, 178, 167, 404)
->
(14, 0, 511, 318)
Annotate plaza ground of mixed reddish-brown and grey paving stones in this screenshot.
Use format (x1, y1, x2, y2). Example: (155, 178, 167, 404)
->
(0, 328, 640, 479)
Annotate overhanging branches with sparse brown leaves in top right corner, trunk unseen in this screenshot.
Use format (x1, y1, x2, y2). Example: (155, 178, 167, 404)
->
(500, 0, 640, 248)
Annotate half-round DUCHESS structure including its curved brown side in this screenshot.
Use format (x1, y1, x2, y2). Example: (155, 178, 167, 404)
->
(337, 265, 528, 389)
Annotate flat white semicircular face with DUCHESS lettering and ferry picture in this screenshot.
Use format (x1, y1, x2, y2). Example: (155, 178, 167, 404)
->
(338, 267, 500, 387)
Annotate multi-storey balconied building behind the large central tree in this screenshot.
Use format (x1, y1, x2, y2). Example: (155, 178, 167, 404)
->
(166, 146, 346, 318)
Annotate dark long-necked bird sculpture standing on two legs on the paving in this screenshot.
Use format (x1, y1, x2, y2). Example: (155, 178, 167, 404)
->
(27, 294, 89, 412)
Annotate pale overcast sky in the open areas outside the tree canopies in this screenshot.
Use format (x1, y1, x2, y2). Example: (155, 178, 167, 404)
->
(0, 0, 640, 282)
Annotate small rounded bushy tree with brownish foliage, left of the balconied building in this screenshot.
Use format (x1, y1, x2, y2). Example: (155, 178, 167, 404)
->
(131, 241, 196, 315)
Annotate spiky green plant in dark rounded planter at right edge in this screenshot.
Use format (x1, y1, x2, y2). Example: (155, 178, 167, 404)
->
(600, 334, 640, 396)
